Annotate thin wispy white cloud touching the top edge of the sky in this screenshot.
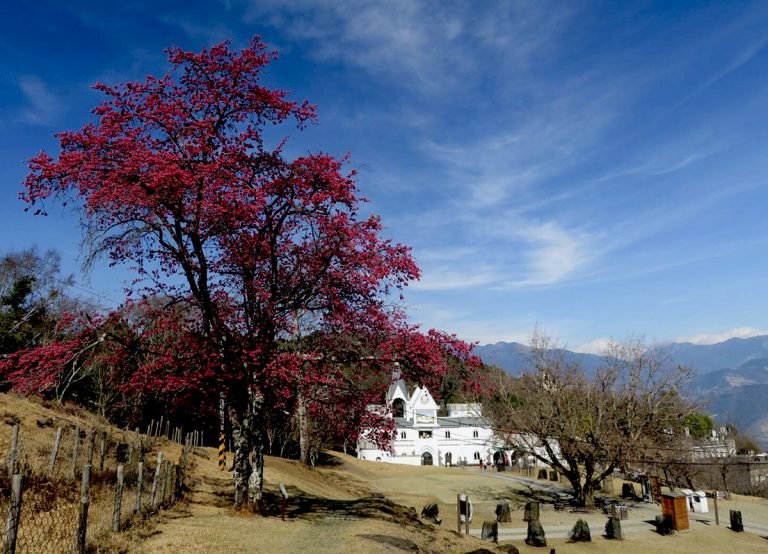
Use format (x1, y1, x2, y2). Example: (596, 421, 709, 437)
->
(245, 0, 569, 91)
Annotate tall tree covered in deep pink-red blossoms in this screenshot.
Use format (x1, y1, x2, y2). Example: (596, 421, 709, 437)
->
(22, 38, 480, 507)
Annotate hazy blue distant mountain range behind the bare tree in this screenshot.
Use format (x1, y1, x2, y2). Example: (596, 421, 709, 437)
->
(475, 336, 768, 448)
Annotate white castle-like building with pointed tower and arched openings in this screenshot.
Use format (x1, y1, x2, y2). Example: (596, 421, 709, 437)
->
(357, 379, 501, 466)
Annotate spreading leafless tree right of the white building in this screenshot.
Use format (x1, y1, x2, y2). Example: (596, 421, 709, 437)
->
(487, 333, 690, 508)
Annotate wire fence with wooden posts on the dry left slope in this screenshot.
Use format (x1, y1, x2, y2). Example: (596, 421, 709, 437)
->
(0, 424, 200, 554)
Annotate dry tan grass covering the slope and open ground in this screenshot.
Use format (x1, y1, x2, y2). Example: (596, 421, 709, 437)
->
(0, 394, 768, 554)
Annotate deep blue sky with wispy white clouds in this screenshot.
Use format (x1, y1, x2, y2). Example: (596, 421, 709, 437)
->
(0, 0, 768, 350)
